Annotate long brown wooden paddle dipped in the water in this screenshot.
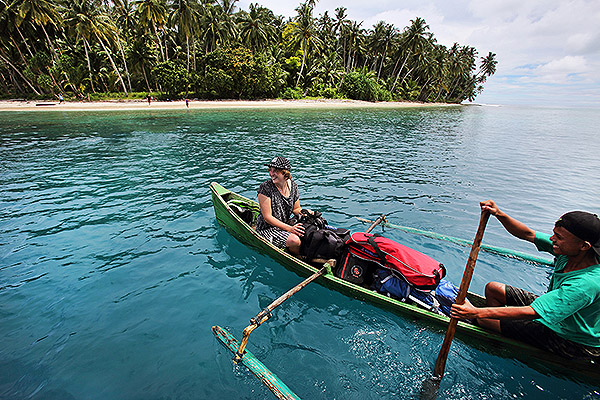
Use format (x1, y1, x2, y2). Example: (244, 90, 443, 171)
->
(421, 210, 490, 399)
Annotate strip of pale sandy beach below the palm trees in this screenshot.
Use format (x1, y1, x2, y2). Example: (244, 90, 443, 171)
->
(0, 99, 460, 111)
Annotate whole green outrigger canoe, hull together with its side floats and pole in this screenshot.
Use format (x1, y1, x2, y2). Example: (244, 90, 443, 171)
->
(210, 182, 600, 399)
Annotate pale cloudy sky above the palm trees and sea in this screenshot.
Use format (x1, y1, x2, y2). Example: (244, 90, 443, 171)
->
(237, 0, 600, 108)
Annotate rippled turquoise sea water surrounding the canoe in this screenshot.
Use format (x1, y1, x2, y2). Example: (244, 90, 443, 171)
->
(0, 106, 600, 400)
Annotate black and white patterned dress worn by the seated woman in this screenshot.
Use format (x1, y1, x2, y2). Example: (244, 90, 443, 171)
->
(256, 179, 300, 249)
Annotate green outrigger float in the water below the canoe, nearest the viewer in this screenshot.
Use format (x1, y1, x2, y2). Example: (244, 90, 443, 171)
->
(212, 326, 300, 400)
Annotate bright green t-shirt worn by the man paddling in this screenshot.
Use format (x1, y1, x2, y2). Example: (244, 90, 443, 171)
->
(531, 232, 600, 347)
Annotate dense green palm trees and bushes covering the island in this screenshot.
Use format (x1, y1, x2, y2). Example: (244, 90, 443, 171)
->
(0, 0, 497, 102)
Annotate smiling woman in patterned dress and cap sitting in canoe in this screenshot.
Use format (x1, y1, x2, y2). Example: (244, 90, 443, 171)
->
(256, 157, 304, 254)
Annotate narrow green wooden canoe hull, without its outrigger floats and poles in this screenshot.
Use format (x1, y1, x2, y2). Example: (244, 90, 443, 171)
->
(210, 182, 600, 382)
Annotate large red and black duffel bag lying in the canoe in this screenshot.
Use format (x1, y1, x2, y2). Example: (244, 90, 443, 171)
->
(336, 232, 446, 290)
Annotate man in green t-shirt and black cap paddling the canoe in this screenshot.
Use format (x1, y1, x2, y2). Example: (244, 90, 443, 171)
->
(451, 200, 600, 360)
